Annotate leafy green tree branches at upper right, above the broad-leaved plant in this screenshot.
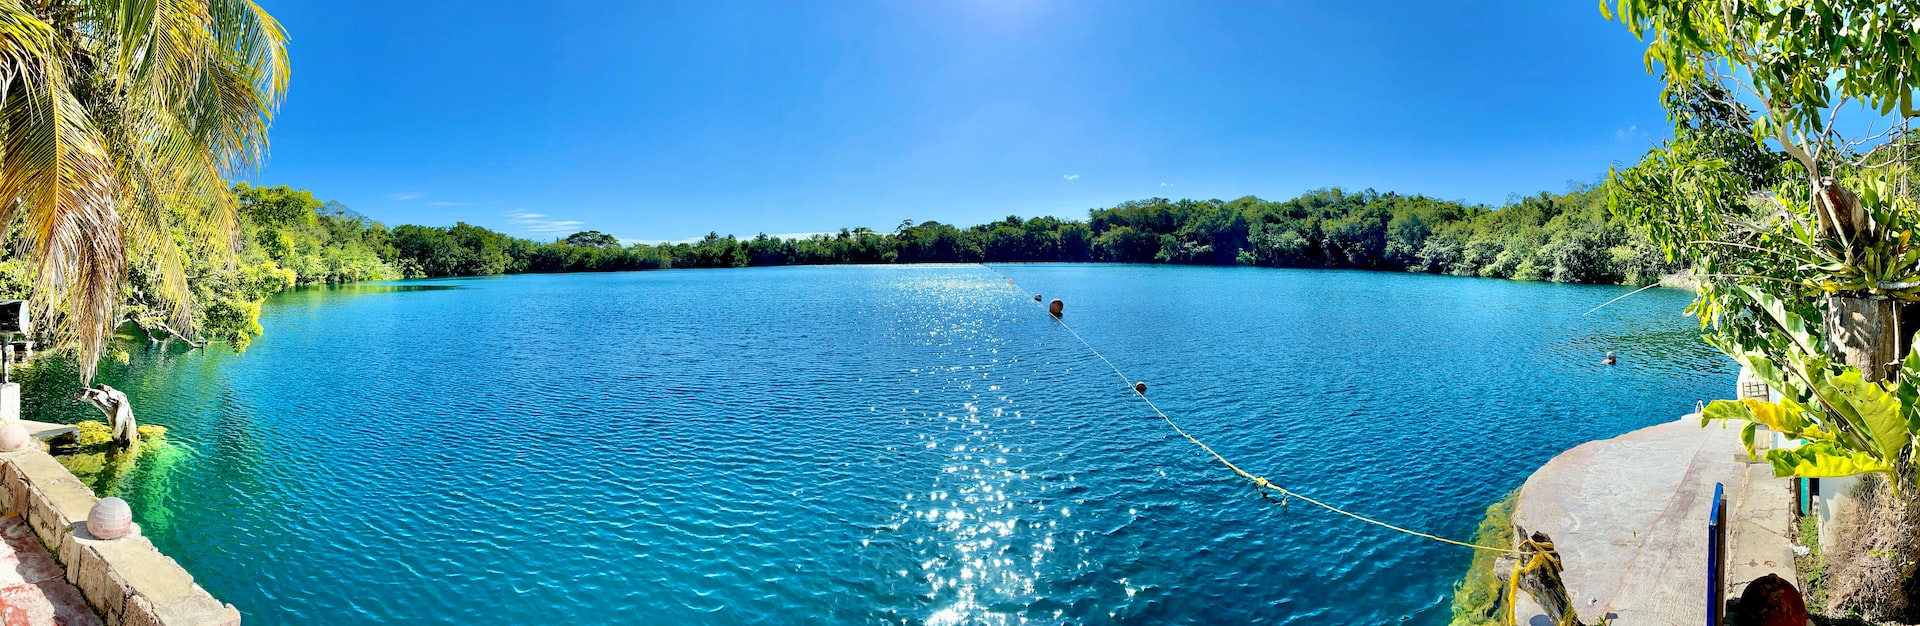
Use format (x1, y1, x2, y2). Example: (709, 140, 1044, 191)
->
(1601, 0, 1920, 332)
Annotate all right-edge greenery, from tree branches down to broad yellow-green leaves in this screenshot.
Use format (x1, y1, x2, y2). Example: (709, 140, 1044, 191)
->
(1601, 0, 1920, 490)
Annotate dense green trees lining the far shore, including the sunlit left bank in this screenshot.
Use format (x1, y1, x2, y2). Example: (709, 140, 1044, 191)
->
(127, 182, 1674, 348)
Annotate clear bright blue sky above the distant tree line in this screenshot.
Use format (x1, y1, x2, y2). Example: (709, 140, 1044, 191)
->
(255, 0, 1667, 242)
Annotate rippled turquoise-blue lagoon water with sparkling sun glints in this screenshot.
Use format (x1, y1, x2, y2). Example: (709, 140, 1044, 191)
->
(86, 265, 1734, 624)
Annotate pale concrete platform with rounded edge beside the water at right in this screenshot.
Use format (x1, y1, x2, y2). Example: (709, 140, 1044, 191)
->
(1513, 415, 1793, 626)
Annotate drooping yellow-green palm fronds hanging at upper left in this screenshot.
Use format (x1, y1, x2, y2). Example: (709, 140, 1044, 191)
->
(0, 0, 288, 378)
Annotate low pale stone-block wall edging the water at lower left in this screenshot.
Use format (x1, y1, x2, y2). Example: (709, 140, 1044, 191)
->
(0, 449, 240, 626)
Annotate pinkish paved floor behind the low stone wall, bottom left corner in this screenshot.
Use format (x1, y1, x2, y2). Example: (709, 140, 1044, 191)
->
(0, 515, 100, 626)
